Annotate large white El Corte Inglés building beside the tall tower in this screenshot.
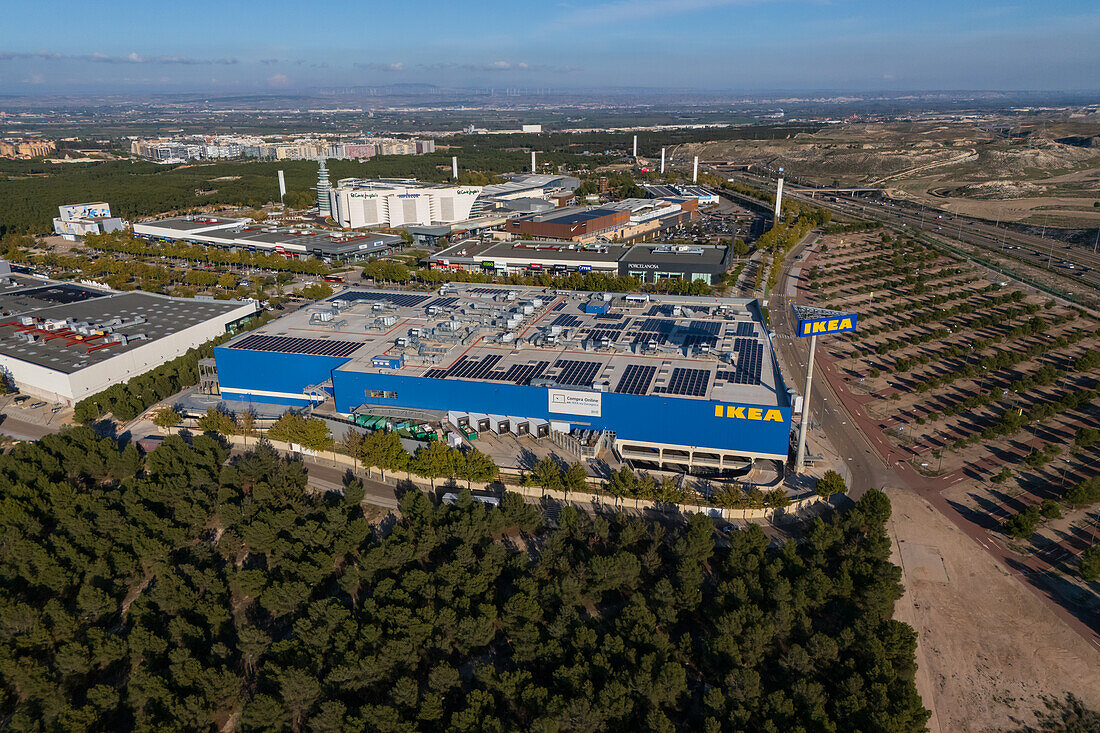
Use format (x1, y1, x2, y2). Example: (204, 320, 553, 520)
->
(329, 178, 482, 229)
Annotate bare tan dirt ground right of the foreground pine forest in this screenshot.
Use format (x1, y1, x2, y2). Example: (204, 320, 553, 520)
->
(887, 490, 1100, 733)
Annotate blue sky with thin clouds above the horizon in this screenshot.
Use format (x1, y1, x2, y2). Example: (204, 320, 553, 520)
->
(0, 0, 1100, 94)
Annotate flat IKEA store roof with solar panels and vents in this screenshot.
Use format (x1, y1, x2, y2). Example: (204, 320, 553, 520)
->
(226, 283, 789, 409)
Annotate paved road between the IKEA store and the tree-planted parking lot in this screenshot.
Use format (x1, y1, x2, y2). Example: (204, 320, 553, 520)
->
(769, 234, 1100, 648)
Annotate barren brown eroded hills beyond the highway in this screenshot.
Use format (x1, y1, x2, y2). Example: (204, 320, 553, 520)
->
(690, 116, 1100, 227)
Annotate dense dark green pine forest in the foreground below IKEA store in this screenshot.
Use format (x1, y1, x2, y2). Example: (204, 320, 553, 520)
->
(0, 427, 928, 733)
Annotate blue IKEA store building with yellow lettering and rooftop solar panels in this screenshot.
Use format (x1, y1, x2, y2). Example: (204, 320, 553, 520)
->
(215, 288, 792, 472)
